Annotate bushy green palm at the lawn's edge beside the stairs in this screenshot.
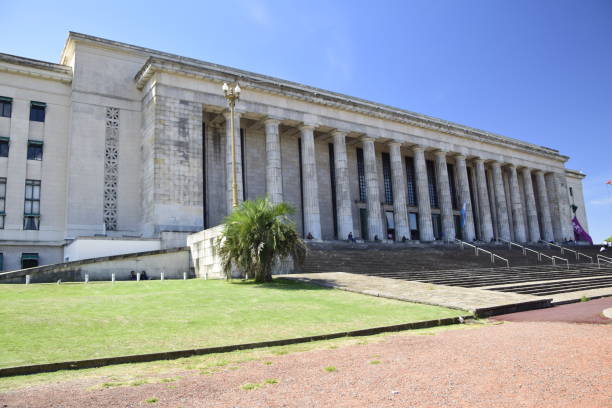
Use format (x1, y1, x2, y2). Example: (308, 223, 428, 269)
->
(216, 197, 306, 282)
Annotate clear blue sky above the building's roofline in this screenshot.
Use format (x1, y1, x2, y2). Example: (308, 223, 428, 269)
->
(0, 0, 612, 241)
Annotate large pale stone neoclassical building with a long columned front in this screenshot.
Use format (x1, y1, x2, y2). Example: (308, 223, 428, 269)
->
(0, 32, 587, 270)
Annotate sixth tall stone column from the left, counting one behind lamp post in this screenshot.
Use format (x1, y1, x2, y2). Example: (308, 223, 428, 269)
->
(389, 142, 410, 241)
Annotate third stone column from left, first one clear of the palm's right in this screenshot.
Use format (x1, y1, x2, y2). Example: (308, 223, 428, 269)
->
(300, 125, 321, 239)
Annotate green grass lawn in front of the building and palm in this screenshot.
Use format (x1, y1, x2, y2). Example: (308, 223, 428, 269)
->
(0, 279, 464, 367)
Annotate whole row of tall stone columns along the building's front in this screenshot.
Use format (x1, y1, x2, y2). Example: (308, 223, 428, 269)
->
(221, 113, 573, 242)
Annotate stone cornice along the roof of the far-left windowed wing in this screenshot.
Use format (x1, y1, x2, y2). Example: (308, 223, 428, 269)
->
(0, 53, 72, 83)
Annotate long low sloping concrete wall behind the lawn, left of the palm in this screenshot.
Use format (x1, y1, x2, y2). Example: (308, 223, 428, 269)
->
(0, 247, 194, 283)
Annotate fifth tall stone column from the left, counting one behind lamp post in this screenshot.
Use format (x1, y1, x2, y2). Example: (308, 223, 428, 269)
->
(363, 137, 386, 241)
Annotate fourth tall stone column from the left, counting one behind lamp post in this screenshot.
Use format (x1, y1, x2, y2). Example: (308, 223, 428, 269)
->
(333, 131, 353, 239)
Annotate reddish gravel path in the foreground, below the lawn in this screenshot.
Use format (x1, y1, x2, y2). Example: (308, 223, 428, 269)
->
(0, 322, 612, 408)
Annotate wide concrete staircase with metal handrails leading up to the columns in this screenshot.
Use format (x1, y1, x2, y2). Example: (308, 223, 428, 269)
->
(303, 242, 612, 296)
